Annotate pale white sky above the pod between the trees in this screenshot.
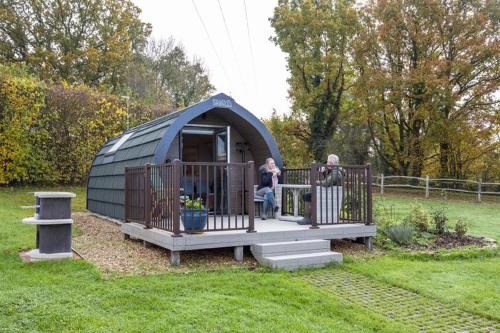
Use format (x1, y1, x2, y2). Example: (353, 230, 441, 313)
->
(133, 0, 290, 118)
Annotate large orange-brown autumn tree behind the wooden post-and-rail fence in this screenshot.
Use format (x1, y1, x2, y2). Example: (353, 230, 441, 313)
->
(354, 0, 499, 178)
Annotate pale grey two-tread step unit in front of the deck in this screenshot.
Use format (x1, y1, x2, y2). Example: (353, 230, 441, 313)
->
(250, 239, 343, 270)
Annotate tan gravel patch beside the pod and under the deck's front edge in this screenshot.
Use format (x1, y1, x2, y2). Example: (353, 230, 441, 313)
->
(73, 213, 257, 275)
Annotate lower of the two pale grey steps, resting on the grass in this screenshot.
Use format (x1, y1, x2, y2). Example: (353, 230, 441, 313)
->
(259, 251, 343, 271)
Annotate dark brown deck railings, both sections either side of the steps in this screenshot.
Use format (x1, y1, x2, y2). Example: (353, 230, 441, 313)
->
(125, 161, 372, 236)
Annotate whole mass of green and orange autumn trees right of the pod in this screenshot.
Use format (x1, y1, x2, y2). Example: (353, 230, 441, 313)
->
(271, 0, 500, 180)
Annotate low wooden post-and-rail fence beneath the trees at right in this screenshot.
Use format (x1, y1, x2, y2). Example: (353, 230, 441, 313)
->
(373, 174, 500, 202)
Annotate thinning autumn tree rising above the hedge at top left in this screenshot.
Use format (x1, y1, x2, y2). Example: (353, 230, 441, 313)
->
(0, 0, 151, 90)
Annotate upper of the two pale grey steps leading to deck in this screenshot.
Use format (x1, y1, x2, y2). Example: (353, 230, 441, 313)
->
(250, 239, 330, 258)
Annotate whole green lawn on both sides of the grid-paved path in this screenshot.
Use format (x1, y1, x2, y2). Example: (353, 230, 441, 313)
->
(0, 188, 500, 332)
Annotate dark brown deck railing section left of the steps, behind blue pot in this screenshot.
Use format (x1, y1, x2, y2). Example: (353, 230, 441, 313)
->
(125, 161, 255, 235)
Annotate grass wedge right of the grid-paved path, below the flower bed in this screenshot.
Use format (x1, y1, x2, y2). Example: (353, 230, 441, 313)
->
(345, 255, 500, 320)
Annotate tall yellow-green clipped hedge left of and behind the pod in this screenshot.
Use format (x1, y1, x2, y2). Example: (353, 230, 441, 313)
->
(0, 65, 170, 184)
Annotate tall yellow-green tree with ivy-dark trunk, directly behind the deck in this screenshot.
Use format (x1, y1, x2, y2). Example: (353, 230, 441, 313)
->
(271, 0, 358, 161)
